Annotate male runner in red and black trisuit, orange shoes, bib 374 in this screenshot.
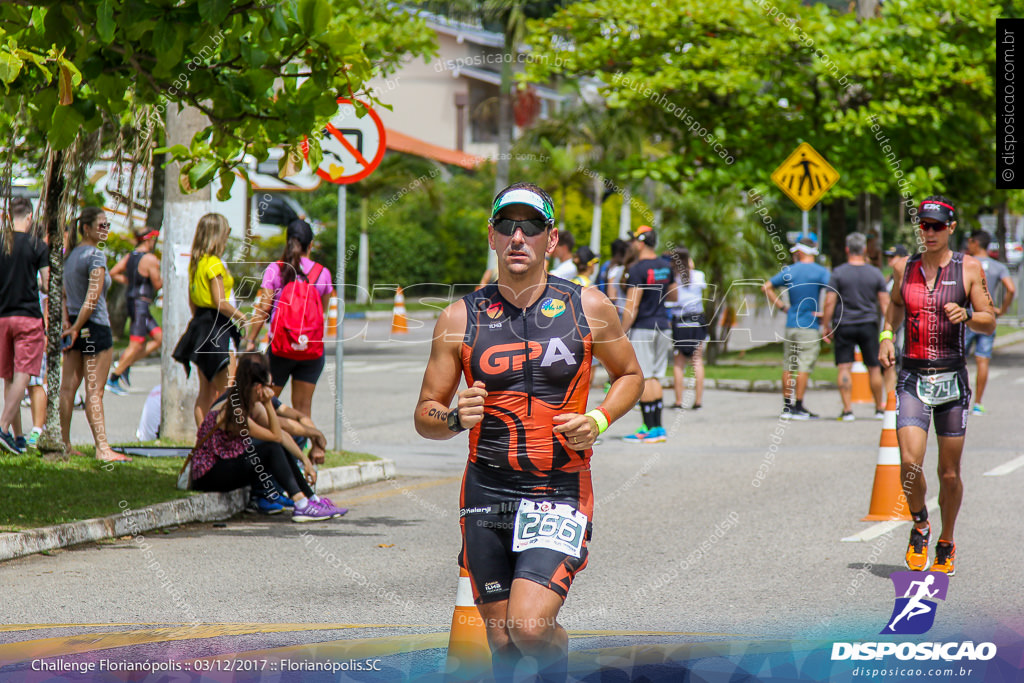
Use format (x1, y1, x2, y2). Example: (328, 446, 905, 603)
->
(879, 195, 995, 575)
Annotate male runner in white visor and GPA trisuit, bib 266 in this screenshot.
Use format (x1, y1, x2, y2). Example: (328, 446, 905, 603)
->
(415, 183, 642, 680)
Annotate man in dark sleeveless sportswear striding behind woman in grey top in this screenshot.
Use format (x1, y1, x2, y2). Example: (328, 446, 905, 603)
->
(106, 226, 164, 396)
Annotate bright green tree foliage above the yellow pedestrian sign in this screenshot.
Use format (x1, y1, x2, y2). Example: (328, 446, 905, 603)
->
(527, 0, 1015, 216)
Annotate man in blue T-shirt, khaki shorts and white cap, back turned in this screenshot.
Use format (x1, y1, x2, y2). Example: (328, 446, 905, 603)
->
(763, 238, 828, 420)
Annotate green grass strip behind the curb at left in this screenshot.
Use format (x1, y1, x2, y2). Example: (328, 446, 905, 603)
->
(0, 441, 379, 531)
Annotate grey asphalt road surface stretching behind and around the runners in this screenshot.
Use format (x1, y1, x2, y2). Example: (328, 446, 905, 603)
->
(0, 313, 1024, 679)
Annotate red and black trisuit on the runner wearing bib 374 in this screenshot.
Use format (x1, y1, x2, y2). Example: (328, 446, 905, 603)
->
(896, 252, 971, 436)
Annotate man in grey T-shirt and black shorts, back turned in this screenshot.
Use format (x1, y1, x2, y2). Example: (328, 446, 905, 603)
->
(821, 232, 889, 422)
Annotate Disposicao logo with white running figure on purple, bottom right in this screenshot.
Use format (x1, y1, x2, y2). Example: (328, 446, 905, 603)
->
(831, 571, 996, 661)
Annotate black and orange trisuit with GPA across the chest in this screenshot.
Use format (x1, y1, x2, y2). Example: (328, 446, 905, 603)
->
(459, 276, 594, 603)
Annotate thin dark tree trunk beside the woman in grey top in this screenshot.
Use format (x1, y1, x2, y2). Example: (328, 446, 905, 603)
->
(37, 151, 68, 459)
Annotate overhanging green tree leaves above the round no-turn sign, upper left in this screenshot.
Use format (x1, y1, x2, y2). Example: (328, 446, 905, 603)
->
(0, 0, 435, 188)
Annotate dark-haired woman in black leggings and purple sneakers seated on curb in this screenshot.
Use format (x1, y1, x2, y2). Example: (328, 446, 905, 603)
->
(191, 353, 348, 522)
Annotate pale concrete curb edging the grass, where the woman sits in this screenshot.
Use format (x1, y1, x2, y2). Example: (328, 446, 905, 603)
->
(0, 460, 396, 562)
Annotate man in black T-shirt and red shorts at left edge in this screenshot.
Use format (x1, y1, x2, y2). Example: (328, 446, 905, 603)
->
(0, 197, 50, 455)
